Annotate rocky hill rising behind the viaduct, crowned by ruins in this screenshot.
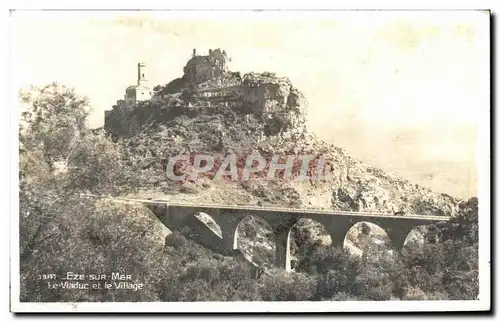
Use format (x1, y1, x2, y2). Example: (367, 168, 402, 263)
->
(100, 50, 460, 261)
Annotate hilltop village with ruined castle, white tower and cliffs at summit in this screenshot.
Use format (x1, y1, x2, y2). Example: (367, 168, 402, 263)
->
(104, 48, 307, 137)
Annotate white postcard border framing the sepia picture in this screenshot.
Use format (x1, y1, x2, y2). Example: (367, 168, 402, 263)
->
(6, 1, 491, 312)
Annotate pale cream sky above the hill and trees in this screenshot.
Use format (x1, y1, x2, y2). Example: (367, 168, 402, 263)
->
(11, 11, 489, 198)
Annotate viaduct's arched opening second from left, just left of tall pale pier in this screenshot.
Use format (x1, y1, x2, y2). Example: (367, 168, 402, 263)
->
(234, 216, 276, 268)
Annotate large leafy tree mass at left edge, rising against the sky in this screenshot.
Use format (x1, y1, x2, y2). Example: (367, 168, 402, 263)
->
(19, 83, 139, 272)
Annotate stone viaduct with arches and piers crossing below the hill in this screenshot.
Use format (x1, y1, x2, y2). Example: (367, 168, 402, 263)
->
(128, 199, 450, 271)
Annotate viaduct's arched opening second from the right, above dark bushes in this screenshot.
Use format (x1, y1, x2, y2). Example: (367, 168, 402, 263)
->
(344, 221, 392, 257)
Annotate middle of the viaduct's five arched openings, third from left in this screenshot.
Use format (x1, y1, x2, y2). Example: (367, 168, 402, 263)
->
(290, 218, 332, 271)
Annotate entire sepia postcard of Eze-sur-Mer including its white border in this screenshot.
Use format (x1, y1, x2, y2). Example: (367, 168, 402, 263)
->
(9, 10, 491, 313)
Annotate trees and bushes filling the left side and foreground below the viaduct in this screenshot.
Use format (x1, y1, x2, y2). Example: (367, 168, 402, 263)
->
(19, 84, 478, 302)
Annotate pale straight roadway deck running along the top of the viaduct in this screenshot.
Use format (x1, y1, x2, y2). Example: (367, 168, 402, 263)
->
(108, 198, 451, 221)
